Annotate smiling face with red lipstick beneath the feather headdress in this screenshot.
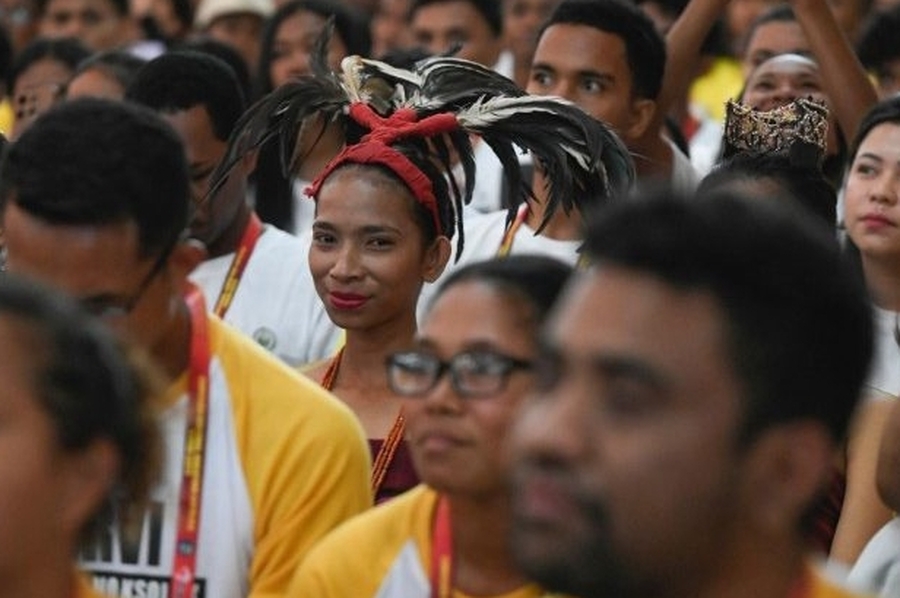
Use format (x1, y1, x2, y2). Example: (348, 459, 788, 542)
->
(309, 167, 449, 330)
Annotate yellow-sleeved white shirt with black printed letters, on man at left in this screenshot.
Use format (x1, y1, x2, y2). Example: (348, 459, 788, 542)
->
(80, 315, 372, 598)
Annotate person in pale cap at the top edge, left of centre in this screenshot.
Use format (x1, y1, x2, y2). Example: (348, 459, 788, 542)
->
(194, 0, 275, 73)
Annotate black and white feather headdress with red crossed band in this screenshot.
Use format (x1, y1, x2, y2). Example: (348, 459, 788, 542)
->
(211, 23, 634, 250)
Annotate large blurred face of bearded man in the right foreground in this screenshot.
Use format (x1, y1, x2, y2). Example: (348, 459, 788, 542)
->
(512, 268, 741, 596)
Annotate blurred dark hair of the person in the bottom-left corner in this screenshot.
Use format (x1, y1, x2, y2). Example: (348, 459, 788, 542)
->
(0, 274, 160, 540)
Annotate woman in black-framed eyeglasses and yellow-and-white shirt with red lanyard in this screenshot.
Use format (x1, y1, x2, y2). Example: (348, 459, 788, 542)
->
(287, 255, 571, 598)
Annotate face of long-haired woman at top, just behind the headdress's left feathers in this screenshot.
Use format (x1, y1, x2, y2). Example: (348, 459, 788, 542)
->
(269, 10, 347, 87)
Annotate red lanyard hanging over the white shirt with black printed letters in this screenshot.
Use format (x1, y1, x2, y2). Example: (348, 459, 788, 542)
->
(169, 285, 209, 598)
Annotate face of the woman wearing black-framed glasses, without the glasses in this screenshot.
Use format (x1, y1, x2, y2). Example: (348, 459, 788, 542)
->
(403, 281, 537, 496)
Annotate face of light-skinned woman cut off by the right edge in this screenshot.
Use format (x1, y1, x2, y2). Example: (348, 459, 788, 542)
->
(844, 123, 900, 263)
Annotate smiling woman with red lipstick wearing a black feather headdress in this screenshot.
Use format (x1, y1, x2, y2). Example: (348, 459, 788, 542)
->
(211, 45, 628, 500)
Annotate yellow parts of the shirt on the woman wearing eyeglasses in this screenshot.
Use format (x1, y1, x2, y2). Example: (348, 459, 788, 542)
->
(286, 485, 544, 598)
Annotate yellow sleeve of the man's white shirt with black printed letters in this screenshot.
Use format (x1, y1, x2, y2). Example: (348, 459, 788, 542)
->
(209, 317, 372, 597)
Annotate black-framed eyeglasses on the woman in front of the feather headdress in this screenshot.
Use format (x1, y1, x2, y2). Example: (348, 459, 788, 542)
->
(387, 351, 533, 397)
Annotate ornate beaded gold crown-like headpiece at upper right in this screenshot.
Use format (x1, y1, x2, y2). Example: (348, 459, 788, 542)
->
(725, 98, 828, 162)
